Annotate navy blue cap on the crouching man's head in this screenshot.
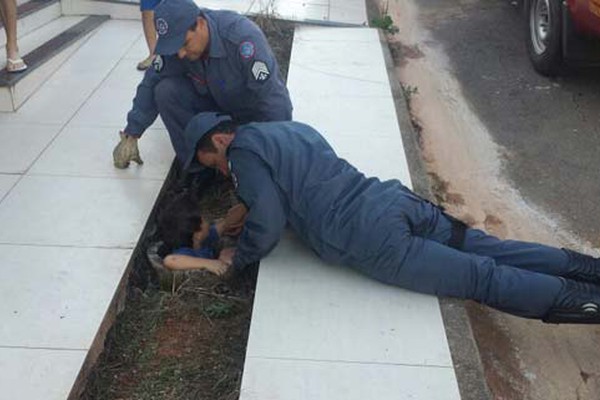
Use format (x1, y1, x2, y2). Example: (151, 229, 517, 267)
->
(154, 0, 200, 56)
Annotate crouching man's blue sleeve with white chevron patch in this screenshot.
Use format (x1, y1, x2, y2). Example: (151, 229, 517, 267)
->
(238, 20, 292, 122)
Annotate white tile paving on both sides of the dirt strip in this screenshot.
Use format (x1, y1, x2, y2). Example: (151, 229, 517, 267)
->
(0, 6, 459, 400)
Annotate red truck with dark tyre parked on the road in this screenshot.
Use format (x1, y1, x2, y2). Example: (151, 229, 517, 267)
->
(523, 0, 600, 76)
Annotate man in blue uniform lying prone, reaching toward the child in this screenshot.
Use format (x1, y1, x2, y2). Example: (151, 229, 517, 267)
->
(179, 113, 600, 323)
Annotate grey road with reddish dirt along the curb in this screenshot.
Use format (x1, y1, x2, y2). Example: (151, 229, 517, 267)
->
(380, 0, 600, 400)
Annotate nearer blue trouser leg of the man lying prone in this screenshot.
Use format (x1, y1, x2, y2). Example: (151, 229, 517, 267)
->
(365, 224, 564, 318)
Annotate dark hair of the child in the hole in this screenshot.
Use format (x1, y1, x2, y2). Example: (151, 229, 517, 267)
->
(158, 193, 202, 249)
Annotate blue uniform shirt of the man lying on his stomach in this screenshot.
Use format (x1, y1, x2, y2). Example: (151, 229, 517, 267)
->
(228, 122, 428, 269)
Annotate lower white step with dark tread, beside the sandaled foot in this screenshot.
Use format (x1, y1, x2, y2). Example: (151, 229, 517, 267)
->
(0, 16, 108, 112)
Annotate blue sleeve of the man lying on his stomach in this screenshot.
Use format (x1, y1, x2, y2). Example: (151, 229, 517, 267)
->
(231, 150, 287, 271)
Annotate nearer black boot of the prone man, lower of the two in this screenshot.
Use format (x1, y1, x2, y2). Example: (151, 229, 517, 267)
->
(542, 279, 600, 324)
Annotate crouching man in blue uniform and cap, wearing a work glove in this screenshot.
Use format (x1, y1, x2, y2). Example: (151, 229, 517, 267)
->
(113, 0, 292, 168)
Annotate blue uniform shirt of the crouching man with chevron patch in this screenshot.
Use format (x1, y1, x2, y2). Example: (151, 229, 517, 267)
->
(125, 9, 292, 137)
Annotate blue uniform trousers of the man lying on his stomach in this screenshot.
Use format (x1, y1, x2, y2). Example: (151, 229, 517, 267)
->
(364, 196, 569, 318)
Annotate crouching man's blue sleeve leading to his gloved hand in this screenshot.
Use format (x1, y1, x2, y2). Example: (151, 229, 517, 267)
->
(125, 56, 184, 137)
